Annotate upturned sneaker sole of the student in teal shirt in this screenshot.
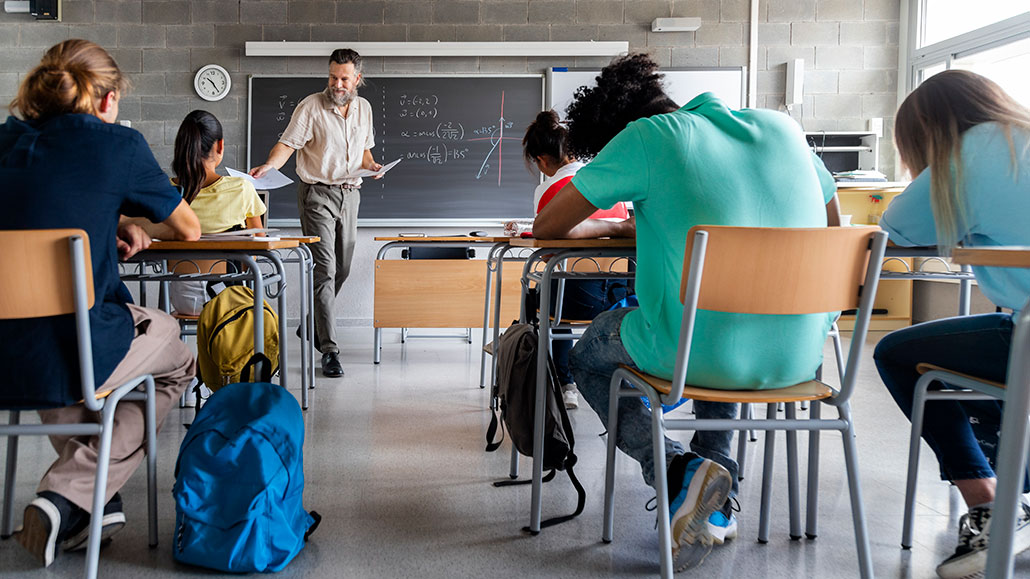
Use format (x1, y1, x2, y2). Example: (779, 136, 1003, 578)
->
(673, 462, 732, 572)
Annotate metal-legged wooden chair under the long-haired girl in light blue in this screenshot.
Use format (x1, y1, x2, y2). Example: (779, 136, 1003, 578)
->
(901, 364, 1005, 549)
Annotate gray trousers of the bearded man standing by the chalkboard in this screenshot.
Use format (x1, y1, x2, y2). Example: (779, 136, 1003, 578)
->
(297, 181, 362, 353)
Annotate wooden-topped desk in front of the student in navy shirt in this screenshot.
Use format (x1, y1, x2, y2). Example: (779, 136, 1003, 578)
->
(123, 238, 310, 409)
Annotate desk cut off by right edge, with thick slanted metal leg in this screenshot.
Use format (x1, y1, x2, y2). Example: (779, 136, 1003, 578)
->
(952, 246, 1030, 579)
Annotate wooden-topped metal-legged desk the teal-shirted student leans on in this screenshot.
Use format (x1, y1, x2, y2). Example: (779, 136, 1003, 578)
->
(494, 237, 637, 534)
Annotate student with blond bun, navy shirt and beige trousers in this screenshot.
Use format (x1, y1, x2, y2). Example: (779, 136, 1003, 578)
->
(0, 39, 200, 566)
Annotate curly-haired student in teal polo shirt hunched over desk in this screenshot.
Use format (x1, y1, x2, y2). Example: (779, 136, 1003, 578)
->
(534, 55, 838, 570)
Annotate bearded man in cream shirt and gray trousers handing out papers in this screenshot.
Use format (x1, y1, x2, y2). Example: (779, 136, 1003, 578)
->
(250, 48, 382, 378)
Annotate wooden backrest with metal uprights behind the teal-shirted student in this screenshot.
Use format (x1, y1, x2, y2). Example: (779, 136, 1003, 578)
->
(662, 226, 887, 404)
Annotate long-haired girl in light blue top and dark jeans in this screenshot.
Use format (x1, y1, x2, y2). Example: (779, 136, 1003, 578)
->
(873, 70, 1030, 578)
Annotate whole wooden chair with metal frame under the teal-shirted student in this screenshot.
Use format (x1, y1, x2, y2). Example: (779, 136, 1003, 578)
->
(603, 226, 887, 578)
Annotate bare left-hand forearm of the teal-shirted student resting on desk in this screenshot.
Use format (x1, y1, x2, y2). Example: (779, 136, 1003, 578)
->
(533, 182, 637, 239)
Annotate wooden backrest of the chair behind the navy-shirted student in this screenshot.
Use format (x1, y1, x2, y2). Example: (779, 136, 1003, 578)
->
(0, 229, 94, 319)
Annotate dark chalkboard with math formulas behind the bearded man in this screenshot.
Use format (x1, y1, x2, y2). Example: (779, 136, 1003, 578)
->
(247, 74, 544, 225)
